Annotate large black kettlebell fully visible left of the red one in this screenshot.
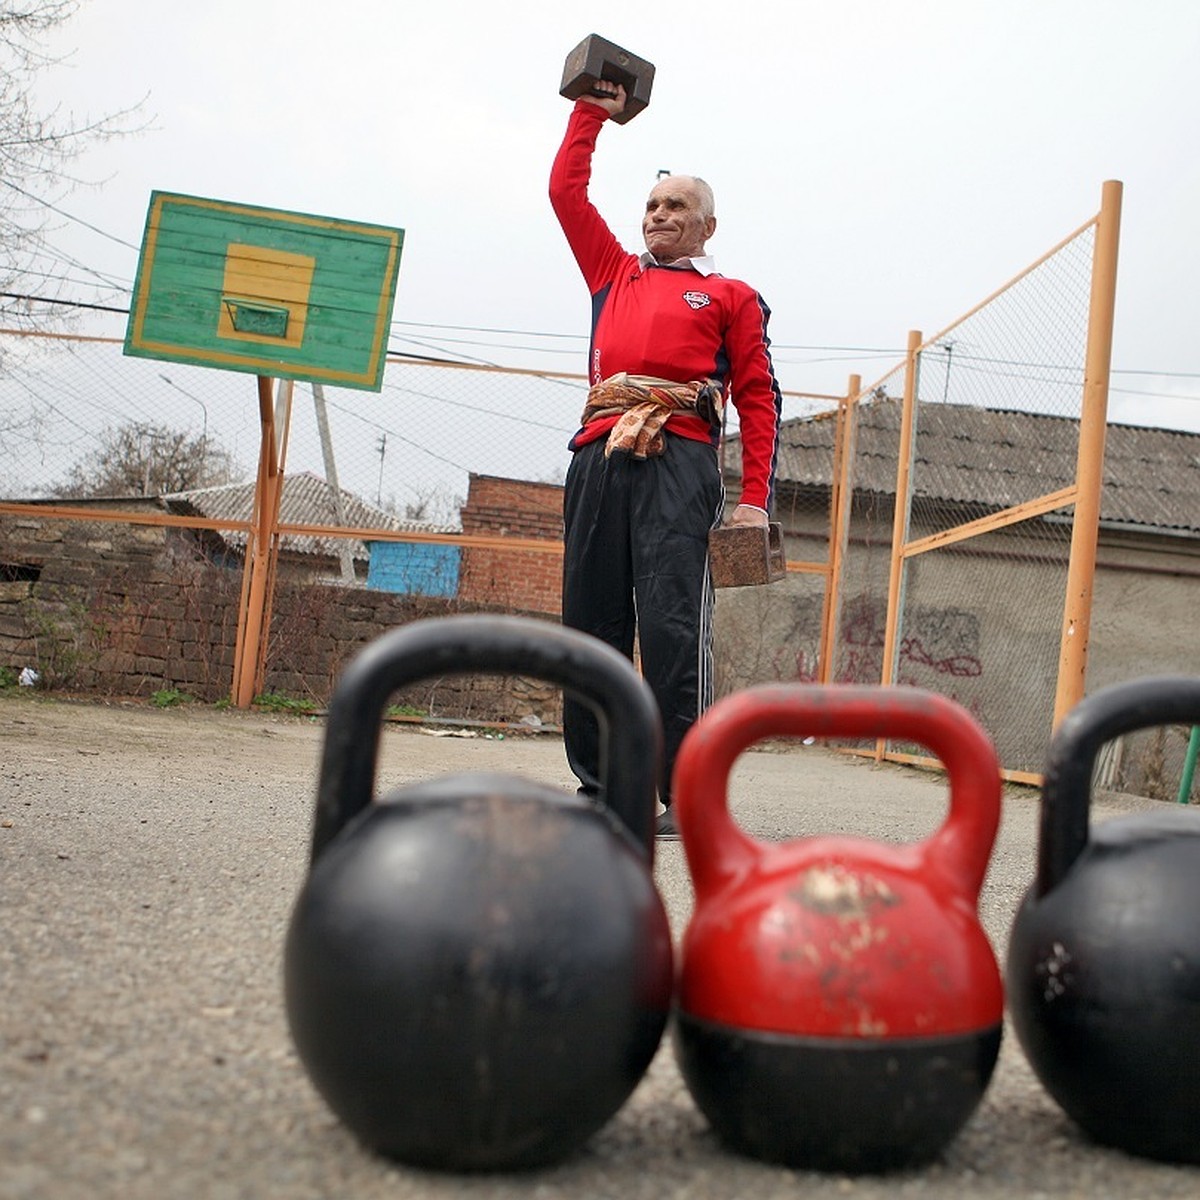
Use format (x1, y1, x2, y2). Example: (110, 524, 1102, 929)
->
(284, 617, 673, 1171)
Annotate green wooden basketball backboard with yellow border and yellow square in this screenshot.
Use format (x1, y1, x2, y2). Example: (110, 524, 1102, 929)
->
(125, 192, 404, 391)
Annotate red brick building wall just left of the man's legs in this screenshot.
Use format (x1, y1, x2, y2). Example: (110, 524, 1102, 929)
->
(458, 475, 563, 617)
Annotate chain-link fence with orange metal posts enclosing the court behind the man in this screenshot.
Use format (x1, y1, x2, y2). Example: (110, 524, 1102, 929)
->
(0, 177, 1186, 778)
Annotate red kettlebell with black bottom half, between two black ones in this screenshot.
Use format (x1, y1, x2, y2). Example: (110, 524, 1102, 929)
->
(673, 684, 1004, 1174)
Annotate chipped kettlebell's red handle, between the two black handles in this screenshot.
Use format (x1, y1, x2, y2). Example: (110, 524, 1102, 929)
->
(672, 684, 1001, 900)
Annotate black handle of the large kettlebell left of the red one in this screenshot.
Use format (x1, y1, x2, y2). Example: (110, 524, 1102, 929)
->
(312, 616, 662, 862)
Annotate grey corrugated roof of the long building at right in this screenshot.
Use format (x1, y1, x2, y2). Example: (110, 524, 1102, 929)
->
(731, 401, 1200, 533)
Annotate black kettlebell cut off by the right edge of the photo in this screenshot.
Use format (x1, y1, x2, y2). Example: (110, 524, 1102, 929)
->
(1007, 676, 1200, 1163)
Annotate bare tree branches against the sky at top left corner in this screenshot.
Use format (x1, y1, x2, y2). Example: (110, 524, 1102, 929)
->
(0, 0, 140, 325)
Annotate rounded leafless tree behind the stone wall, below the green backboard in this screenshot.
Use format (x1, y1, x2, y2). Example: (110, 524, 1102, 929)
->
(52, 422, 236, 499)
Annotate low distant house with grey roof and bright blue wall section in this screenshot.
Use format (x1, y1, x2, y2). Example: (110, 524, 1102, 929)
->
(162, 472, 458, 596)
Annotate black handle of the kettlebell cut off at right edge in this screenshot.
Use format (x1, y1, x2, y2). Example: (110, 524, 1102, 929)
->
(1034, 676, 1200, 896)
